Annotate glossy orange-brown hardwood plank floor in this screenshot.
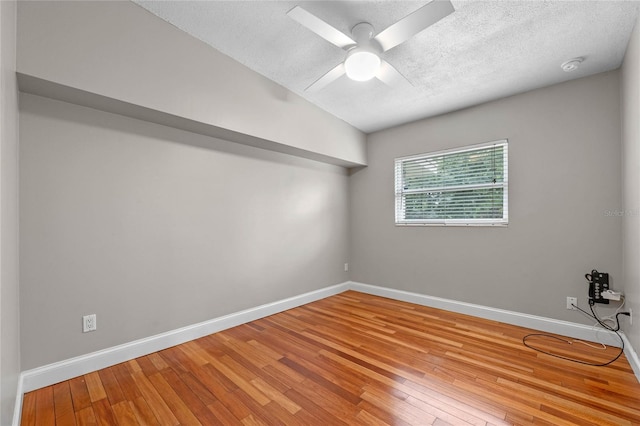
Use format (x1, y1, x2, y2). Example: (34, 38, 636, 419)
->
(22, 291, 640, 426)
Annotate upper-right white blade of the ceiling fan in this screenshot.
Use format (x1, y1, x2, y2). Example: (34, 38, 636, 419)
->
(374, 0, 455, 52)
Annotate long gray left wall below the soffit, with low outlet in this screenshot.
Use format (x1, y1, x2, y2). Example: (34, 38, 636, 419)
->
(20, 94, 348, 370)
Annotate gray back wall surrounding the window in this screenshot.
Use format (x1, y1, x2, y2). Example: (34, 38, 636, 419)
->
(350, 71, 622, 322)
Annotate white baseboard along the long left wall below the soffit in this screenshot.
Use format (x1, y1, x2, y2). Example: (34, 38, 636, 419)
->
(19, 282, 349, 399)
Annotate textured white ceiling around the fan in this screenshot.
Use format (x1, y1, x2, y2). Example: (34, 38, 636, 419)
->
(134, 0, 640, 133)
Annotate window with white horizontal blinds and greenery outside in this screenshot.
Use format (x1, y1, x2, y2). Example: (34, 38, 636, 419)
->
(395, 140, 509, 225)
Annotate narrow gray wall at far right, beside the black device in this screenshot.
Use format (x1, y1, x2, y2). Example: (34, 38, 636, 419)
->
(620, 15, 640, 351)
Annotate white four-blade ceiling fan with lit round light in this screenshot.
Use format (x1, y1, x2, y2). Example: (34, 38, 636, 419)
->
(287, 0, 454, 91)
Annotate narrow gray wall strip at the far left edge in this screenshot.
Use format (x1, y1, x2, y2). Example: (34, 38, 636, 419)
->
(0, 1, 20, 425)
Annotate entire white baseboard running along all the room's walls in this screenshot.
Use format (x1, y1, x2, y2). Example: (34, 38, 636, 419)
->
(13, 281, 640, 426)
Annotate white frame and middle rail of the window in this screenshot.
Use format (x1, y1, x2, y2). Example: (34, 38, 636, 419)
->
(394, 139, 509, 227)
